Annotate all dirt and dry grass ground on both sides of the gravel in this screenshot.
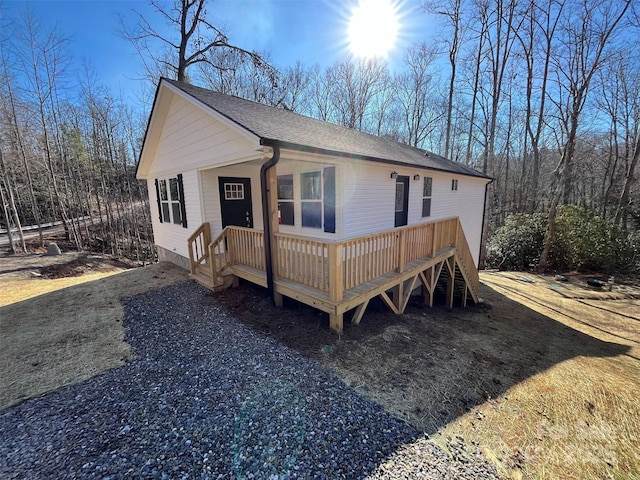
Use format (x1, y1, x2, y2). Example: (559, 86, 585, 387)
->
(0, 249, 640, 479)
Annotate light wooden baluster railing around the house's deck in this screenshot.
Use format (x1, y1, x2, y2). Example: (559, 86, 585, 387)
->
(189, 217, 479, 301)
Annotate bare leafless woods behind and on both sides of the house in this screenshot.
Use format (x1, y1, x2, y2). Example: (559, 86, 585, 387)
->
(0, 0, 640, 269)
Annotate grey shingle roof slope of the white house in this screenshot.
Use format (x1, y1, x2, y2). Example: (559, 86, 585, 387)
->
(162, 78, 489, 178)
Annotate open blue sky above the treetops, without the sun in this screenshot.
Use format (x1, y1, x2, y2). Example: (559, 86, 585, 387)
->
(0, 0, 436, 102)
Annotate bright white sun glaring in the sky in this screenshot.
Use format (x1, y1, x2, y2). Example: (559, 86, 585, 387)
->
(349, 0, 398, 58)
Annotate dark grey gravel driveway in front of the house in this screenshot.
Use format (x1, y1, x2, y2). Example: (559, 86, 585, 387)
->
(0, 282, 497, 479)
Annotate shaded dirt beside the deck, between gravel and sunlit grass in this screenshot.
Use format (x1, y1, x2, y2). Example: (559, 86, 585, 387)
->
(216, 276, 630, 434)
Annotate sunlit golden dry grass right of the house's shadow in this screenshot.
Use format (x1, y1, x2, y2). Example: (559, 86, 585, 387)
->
(436, 274, 640, 479)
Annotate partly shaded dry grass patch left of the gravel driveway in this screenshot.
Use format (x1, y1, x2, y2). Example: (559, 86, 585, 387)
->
(0, 257, 186, 410)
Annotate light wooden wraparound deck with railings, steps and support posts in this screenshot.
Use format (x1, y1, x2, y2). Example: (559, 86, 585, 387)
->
(189, 218, 479, 332)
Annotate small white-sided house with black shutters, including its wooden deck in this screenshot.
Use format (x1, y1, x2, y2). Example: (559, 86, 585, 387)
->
(137, 79, 490, 330)
